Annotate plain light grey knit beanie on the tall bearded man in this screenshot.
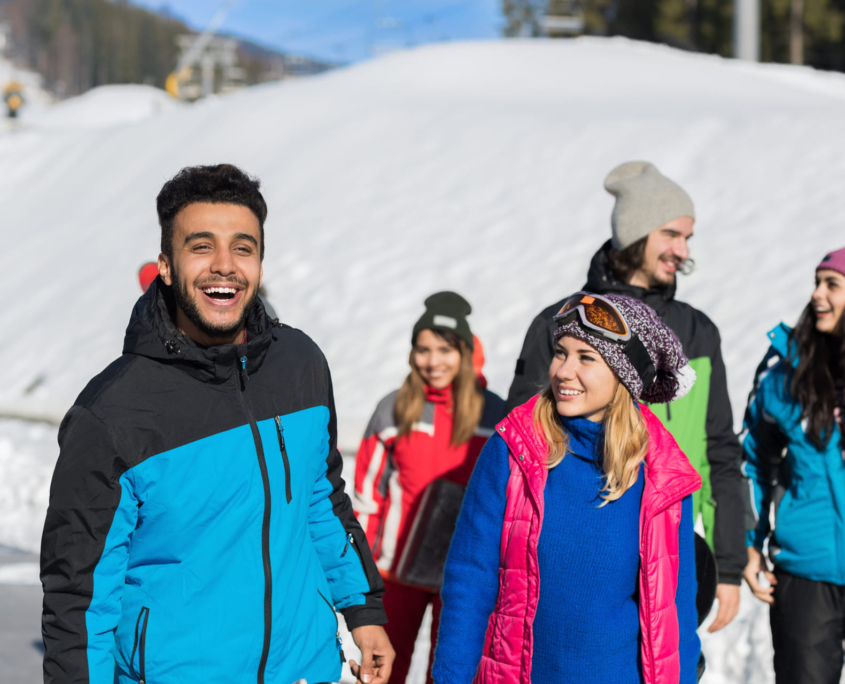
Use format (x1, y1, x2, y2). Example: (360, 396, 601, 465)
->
(604, 162, 695, 249)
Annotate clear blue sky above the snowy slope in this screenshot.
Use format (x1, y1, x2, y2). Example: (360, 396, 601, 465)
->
(133, 0, 502, 62)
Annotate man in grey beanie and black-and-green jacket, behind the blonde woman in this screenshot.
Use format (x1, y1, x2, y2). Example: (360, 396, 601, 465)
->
(507, 161, 748, 632)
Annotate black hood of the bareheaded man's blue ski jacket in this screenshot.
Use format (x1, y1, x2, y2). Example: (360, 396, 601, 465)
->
(123, 276, 278, 384)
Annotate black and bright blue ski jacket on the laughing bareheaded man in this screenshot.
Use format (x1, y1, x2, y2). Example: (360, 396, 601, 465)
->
(41, 280, 386, 684)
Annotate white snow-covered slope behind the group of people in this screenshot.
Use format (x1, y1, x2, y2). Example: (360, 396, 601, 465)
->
(0, 39, 845, 684)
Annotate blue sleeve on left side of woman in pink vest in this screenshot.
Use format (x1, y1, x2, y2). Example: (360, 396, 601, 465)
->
(432, 435, 510, 684)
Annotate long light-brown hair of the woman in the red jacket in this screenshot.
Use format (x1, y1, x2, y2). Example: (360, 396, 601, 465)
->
(394, 330, 484, 446)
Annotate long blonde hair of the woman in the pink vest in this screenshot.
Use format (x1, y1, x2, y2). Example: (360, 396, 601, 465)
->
(534, 382, 648, 506)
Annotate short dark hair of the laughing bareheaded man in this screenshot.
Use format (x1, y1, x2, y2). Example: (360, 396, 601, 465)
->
(156, 164, 267, 260)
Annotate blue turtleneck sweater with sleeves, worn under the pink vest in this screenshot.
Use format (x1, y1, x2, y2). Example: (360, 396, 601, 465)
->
(433, 418, 700, 684)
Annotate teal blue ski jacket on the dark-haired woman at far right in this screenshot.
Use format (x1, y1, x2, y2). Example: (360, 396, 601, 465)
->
(742, 323, 845, 585)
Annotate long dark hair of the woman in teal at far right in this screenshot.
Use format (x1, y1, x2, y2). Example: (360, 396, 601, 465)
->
(788, 302, 845, 450)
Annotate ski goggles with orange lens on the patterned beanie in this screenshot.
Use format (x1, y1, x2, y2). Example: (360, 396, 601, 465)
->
(554, 292, 657, 387)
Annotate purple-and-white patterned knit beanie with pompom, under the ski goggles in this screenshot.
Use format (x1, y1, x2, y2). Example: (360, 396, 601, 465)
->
(554, 293, 695, 404)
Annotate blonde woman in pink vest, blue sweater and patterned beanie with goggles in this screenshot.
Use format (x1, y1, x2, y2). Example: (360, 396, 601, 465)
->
(433, 292, 701, 684)
